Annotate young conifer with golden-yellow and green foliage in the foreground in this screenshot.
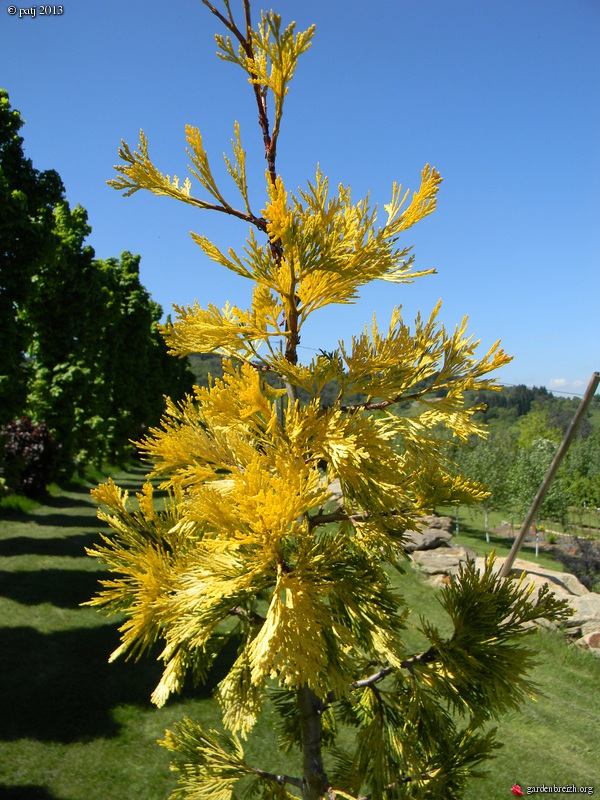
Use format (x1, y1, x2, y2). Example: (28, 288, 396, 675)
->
(86, 0, 564, 800)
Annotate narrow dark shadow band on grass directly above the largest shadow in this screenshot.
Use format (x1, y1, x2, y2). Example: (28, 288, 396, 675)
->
(0, 569, 110, 608)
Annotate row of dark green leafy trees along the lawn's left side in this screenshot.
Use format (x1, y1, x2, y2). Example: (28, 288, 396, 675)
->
(0, 90, 193, 488)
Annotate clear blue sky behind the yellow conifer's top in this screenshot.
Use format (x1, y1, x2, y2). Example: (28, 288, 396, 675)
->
(0, 0, 600, 393)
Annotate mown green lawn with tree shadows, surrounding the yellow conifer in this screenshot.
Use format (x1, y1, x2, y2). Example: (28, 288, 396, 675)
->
(0, 469, 600, 800)
